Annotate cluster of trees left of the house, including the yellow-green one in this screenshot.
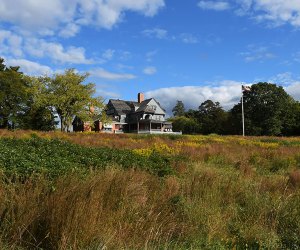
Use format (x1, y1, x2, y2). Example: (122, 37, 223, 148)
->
(0, 58, 103, 131)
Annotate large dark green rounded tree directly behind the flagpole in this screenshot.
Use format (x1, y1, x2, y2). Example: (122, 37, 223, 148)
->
(231, 82, 297, 135)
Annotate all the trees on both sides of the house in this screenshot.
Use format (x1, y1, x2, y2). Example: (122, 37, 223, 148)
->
(0, 58, 300, 136)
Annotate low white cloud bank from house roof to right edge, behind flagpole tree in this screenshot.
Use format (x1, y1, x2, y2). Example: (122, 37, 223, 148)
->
(145, 77, 300, 115)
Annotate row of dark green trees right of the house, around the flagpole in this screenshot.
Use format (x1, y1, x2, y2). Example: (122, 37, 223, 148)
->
(170, 82, 300, 136)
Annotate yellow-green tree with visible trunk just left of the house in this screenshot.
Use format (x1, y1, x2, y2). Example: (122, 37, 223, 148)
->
(43, 69, 103, 131)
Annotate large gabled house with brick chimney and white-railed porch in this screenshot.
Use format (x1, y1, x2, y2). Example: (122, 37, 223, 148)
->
(73, 93, 180, 134)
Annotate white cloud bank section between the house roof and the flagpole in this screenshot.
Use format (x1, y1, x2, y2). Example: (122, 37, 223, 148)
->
(145, 80, 241, 114)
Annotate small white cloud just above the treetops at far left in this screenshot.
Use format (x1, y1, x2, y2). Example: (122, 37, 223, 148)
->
(5, 59, 53, 76)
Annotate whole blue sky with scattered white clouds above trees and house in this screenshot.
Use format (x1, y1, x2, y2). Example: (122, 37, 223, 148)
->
(0, 0, 300, 114)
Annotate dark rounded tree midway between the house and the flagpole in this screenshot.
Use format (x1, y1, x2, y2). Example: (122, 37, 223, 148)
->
(197, 100, 227, 134)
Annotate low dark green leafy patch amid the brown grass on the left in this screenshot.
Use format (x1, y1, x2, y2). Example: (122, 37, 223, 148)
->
(0, 136, 176, 178)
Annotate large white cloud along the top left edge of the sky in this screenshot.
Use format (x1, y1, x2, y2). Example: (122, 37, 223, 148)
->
(0, 0, 165, 36)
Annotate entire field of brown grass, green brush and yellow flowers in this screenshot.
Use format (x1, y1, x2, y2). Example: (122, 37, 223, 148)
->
(0, 130, 300, 250)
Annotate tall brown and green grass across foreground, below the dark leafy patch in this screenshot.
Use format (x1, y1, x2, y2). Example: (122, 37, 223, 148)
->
(0, 164, 300, 249)
